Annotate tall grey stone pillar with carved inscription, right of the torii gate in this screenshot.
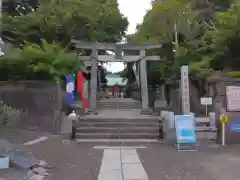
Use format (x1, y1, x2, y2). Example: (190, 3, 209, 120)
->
(181, 66, 190, 114)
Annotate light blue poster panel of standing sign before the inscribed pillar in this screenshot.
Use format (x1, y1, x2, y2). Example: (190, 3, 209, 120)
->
(175, 115, 196, 144)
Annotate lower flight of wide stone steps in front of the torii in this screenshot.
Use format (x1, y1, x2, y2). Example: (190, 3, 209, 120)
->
(76, 110, 158, 142)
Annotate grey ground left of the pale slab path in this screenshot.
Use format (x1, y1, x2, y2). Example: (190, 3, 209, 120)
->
(29, 137, 102, 180)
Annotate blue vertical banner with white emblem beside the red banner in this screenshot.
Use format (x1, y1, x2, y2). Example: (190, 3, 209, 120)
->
(66, 74, 75, 105)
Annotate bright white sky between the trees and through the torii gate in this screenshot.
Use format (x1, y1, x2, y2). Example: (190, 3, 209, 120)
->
(105, 0, 151, 72)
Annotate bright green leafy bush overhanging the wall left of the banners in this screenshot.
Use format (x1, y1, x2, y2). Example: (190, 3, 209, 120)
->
(0, 41, 80, 81)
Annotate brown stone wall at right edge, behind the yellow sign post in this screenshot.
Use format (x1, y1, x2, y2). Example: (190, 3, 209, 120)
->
(208, 72, 240, 144)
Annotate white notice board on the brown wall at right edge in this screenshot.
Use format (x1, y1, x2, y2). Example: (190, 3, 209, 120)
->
(226, 86, 240, 112)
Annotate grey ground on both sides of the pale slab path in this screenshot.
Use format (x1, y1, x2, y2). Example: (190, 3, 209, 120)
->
(0, 129, 240, 180)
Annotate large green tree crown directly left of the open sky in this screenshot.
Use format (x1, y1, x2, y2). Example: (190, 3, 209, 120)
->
(3, 0, 128, 45)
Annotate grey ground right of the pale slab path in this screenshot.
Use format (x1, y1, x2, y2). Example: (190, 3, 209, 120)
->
(138, 144, 240, 180)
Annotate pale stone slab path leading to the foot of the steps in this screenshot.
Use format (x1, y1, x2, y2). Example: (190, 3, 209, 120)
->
(98, 147, 148, 180)
